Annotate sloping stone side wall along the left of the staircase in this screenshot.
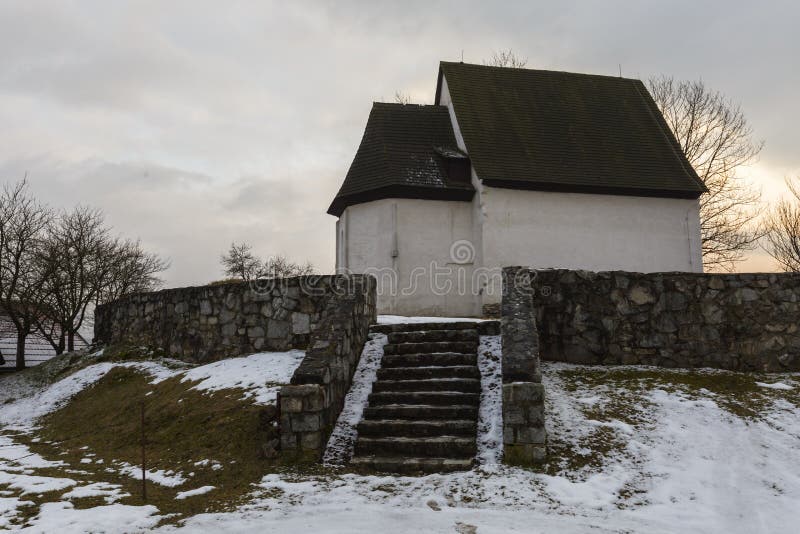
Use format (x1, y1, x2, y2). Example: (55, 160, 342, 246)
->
(279, 276, 377, 460)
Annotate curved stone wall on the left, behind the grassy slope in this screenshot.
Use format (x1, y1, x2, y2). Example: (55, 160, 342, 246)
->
(94, 276, 354, 363)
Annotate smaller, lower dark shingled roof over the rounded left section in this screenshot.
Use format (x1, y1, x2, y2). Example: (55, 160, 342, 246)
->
(328, 102, 475, 216)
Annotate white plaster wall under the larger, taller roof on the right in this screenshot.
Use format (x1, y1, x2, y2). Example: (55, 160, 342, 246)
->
(481, 185, 703, 303)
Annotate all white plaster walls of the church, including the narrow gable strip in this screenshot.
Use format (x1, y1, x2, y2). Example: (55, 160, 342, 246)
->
(336, 78, 702, 316)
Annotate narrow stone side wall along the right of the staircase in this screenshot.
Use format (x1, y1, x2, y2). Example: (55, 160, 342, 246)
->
(500, 267, 546, 465)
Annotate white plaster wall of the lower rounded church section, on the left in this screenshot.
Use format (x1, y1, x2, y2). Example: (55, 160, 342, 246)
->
(337, 199, 481, 316)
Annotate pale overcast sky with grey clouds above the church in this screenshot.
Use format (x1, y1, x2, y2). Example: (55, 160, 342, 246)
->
(0, 0, 800, 286)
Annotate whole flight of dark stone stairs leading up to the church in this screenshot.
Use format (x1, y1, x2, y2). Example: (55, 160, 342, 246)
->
(351, 322, 481, 474)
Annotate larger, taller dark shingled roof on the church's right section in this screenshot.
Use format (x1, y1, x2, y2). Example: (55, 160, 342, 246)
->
(436, 62, 705, 198)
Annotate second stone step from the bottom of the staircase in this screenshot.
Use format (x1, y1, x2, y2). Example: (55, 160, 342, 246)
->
(356, 436, 477, 458)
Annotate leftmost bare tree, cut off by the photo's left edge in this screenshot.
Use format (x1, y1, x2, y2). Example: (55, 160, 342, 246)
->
(0, 180, 52, 369)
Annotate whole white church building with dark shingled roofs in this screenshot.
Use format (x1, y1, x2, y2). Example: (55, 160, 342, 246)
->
(328, 62, 705, 316)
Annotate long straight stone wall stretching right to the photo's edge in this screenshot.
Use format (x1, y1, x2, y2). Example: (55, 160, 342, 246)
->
(534, 270, 800, 372)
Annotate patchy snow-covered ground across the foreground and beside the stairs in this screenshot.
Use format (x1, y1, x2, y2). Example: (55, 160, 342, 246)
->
(0, 337, 800, 534)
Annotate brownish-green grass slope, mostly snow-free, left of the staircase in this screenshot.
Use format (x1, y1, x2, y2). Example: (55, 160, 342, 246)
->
(18, 367, 276, 520)
